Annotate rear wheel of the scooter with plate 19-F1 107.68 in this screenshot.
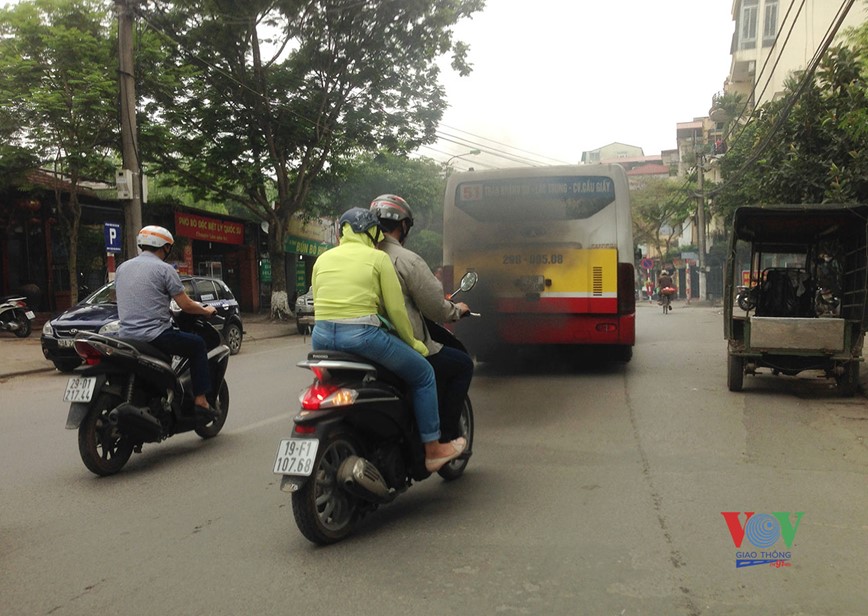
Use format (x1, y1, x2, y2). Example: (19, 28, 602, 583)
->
(292, 432, 362, 545)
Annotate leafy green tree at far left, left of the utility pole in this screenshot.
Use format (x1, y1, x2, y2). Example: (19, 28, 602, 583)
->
(0, 0, 118, 303)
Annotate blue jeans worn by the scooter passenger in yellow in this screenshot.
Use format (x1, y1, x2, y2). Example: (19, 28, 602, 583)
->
(310, 321, 440, 443)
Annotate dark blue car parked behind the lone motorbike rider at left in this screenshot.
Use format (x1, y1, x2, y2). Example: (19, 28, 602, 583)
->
(40, 276, 244, 372)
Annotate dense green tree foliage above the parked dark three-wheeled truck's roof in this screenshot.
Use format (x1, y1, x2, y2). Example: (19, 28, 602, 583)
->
(714, 24, 868, 219)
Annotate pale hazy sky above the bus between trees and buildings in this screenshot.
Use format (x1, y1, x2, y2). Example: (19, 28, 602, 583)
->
(428, 0, 734, 169)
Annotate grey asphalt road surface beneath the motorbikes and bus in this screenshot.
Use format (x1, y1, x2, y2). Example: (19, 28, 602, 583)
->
(0, 303, 868, 616)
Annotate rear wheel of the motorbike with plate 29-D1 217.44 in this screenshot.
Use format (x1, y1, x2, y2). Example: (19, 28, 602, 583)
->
(78, 393, 133, 477)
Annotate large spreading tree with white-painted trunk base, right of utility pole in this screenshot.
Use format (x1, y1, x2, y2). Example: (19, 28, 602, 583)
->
(140, 0, 483, 317)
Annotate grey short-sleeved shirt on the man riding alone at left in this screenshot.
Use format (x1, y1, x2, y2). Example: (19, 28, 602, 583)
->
(115, 251, 184, 342)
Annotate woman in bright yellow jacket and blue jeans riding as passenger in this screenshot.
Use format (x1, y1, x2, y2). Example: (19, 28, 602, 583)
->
(311, 208, 467, 473)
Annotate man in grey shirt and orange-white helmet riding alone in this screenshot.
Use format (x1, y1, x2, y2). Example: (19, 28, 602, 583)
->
(115, 225, 217, 421)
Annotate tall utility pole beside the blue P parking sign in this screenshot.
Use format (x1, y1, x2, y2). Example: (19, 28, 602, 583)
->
(115, 0, 142, 258)
